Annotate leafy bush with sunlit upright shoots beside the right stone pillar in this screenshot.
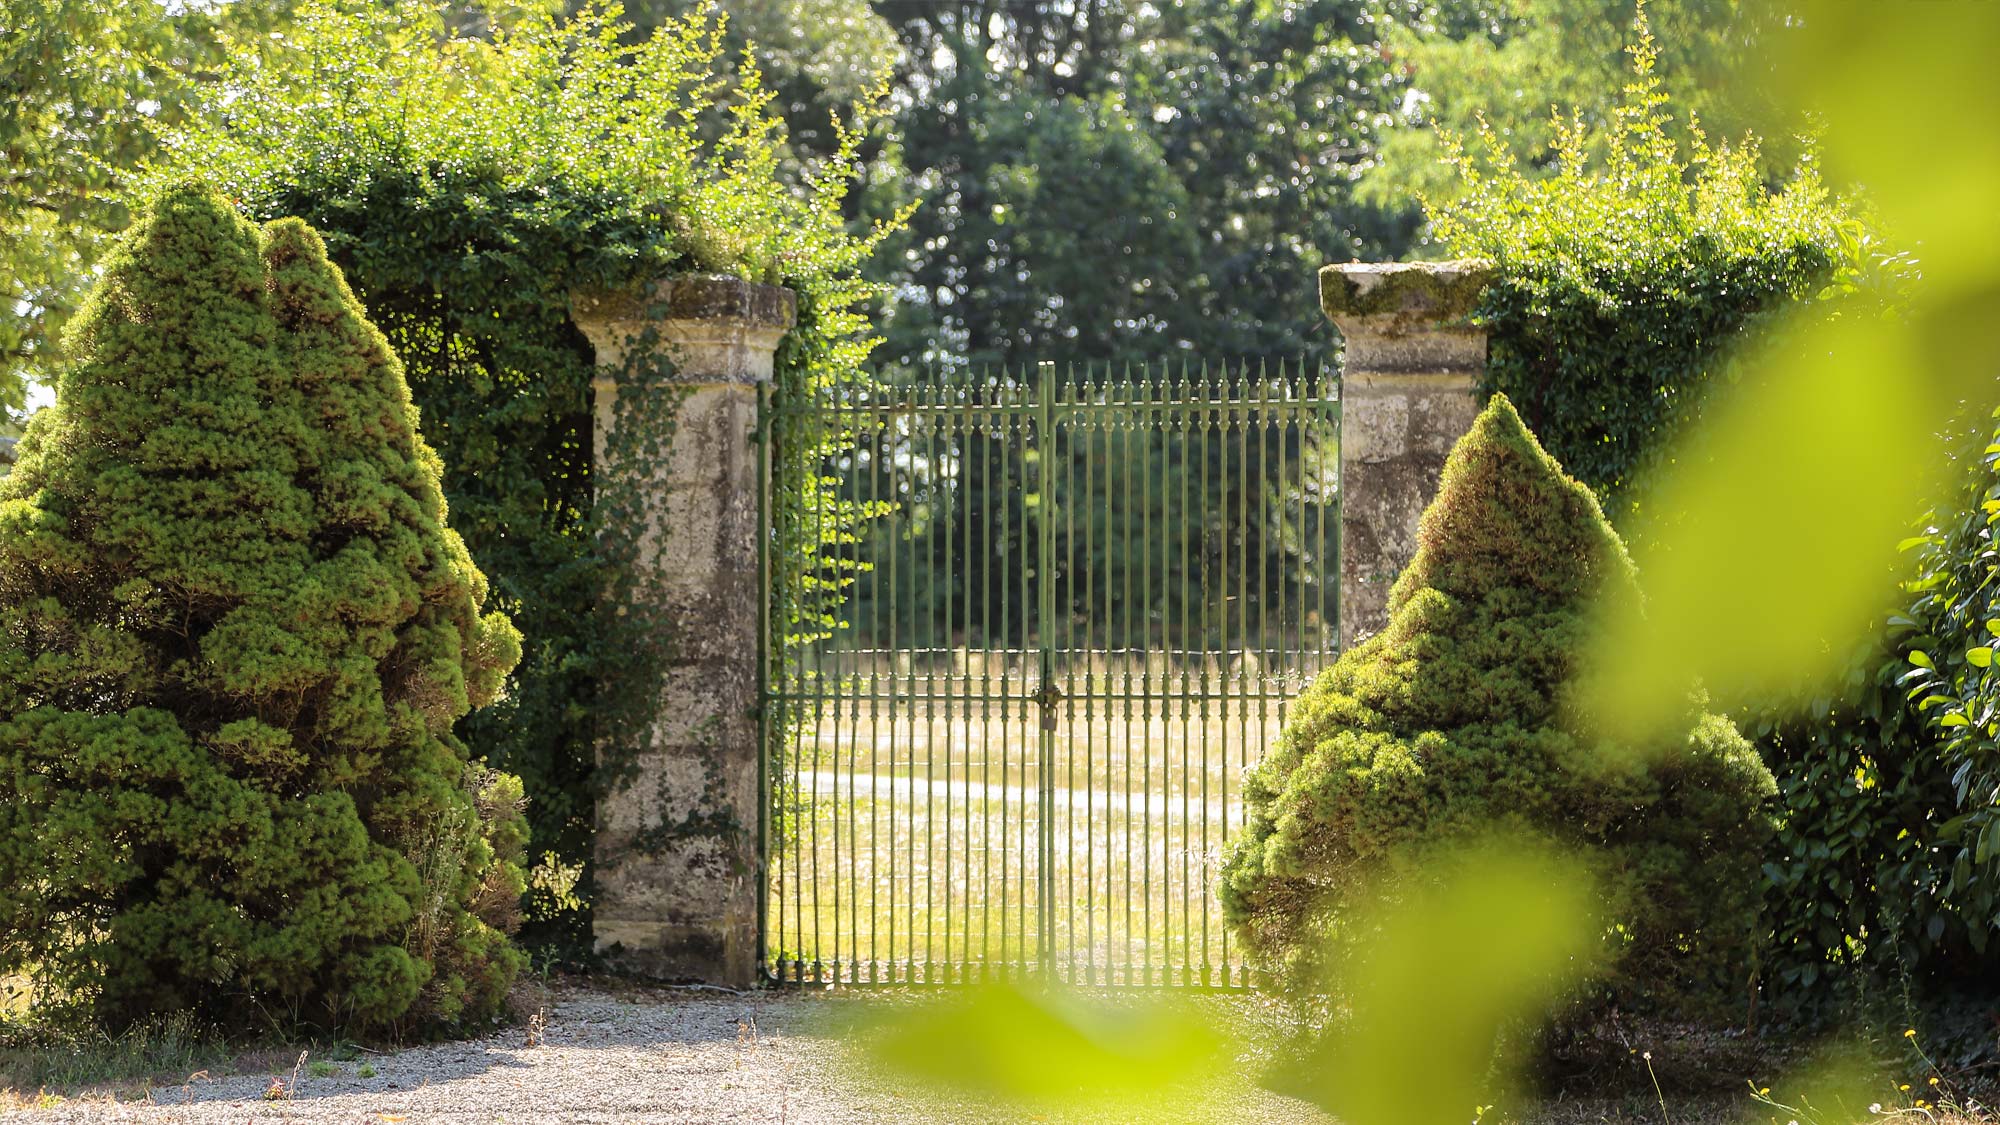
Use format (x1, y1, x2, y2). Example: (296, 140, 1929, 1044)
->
(1430, 16, 1860, 534)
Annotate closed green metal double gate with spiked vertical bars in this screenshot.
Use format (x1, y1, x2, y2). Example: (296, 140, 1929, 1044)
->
(762, 364, 1340, 987)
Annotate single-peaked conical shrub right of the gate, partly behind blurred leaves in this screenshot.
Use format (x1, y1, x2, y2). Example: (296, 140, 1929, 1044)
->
(1222, 396, 1776, 1005)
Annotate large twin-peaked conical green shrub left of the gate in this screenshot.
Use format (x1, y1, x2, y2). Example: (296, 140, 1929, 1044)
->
(0, 188, 524, 1031)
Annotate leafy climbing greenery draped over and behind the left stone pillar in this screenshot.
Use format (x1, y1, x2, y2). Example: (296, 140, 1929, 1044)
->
(164, 6, 896, 955)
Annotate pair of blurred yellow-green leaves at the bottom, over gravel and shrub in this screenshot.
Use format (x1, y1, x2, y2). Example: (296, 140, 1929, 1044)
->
(872, 833, 1596, 1125)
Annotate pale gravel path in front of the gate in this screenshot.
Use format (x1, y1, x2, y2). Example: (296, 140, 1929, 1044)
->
(15, 989, 1328, 1125)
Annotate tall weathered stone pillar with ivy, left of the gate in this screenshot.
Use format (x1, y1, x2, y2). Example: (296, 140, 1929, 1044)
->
(572, 276, 796, 987)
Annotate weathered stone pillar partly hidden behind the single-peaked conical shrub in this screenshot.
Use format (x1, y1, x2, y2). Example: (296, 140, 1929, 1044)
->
(1320, 262, 1492, 645)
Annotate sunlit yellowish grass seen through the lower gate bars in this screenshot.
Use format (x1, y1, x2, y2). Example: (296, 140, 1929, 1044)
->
(768, 675, 1284, 985)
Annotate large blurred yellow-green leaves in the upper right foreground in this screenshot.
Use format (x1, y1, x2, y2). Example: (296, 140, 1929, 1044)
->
(1592, 2, 2000, 727)
